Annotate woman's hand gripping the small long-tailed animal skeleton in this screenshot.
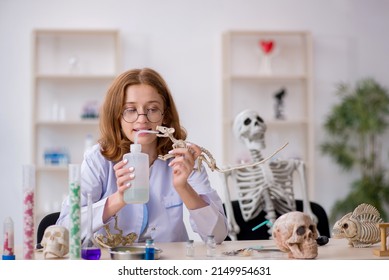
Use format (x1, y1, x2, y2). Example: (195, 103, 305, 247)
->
(169, 144, 201, 189)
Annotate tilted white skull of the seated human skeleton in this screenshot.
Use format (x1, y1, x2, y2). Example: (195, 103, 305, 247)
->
(233, 109, 266, 150)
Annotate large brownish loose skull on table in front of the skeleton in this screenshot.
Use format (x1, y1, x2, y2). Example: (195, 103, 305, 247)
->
(272, 211, 319, 259)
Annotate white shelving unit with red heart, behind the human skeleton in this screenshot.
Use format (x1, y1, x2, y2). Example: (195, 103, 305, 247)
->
(222, 31, 314, 196)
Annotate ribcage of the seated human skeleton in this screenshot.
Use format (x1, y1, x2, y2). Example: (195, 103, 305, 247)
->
(232, 160, 296, 221)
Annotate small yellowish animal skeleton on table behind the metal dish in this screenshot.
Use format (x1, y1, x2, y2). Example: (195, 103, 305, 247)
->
(95, 215, 137, 248)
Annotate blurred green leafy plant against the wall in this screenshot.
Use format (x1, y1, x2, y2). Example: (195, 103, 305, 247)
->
(320, 78, 389, 222)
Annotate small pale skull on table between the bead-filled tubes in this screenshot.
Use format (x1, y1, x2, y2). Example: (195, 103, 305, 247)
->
(41, 225, 69, 259)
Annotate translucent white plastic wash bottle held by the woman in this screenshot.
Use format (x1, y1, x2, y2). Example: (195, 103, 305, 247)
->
(123, 130, 159, 204)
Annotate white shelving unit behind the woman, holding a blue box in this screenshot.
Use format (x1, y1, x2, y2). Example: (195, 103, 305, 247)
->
(32, 30, 120, 222)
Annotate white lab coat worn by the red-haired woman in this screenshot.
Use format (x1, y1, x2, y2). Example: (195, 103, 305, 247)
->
(57, 144, 228, 243)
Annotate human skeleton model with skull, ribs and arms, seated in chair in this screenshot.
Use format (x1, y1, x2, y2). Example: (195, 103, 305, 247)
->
(222, 110, 317, 240)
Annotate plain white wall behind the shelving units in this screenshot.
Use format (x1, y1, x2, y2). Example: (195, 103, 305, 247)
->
(0, 0, 389, 244)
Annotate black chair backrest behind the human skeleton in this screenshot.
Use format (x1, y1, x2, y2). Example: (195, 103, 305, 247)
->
(226, 199, 330, 240)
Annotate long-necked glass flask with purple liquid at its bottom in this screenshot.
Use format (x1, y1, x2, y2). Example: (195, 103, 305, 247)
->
(81, 193, 101, 260)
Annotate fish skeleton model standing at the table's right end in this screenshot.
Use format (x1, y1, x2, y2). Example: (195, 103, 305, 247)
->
(332, 203, 383, 248)
